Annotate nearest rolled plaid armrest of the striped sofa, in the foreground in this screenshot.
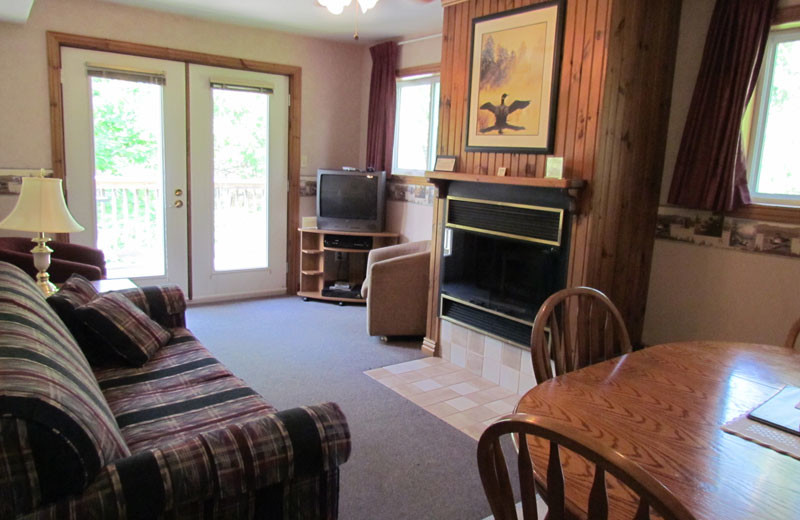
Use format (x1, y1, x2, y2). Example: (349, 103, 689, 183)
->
(22, 403, 350, 520)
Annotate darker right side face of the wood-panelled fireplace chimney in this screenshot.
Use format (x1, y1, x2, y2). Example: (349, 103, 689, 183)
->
(584, 0, 680, 341)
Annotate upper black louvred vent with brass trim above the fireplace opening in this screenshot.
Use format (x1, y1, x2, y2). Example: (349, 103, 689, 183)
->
(447, 197, 564, 246)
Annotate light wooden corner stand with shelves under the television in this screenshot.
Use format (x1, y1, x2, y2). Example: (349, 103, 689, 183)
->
(297, 228, 399, 305)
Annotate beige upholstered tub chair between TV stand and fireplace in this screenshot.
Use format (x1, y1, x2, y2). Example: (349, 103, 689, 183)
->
(361, 240, 431, 336)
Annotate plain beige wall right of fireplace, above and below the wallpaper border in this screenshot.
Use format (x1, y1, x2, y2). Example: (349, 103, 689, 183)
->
(643, 0, 800, 350)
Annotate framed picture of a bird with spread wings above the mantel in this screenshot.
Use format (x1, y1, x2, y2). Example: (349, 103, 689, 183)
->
(466, 0, 564, 153)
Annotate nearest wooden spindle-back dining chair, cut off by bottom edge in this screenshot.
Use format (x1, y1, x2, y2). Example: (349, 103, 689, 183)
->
(478, 414, 694, 520)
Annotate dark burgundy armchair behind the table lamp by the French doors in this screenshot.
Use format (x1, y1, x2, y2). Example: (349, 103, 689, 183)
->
(0, 237, 106, 283)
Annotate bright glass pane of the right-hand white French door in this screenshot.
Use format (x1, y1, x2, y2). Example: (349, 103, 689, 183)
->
(211, 88, 269, 271)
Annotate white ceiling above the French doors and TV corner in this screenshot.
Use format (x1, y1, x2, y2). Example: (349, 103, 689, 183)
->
(97, 0, 442, 43)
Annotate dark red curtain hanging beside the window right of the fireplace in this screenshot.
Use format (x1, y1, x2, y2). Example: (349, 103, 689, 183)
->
(667, 0, 777, 211)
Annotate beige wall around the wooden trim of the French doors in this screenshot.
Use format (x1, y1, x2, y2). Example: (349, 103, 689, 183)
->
(0, 0, 369, 226)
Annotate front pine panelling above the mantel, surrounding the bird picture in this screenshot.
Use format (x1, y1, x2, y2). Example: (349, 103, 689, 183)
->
(439, 0, 610, 179)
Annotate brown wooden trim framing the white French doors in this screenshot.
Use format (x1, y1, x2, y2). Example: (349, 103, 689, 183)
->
(46, 31, 302, 294)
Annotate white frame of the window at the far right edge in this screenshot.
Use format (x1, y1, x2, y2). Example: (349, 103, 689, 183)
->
(747, 27, 800, 207)
